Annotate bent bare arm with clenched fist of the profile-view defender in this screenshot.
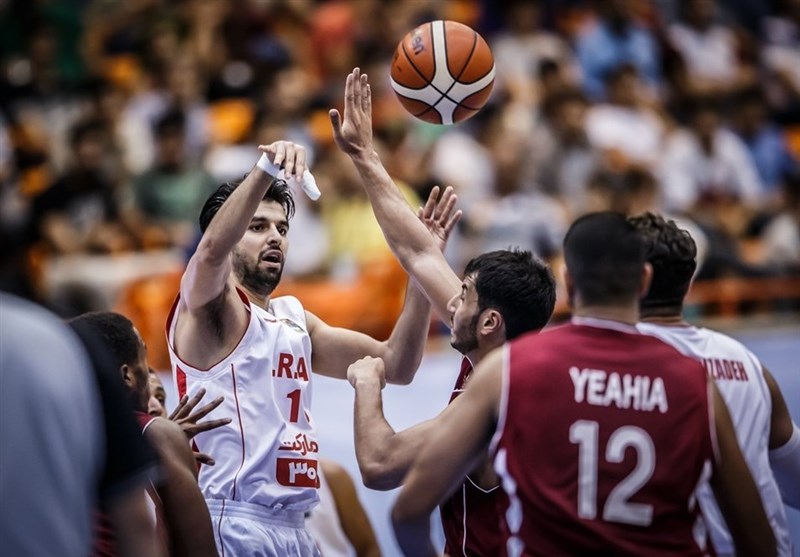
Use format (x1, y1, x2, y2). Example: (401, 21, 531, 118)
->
(347, 358, 461, 490)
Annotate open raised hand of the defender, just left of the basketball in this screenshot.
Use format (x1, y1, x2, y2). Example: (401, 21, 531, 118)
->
(328, 68, 372, 159)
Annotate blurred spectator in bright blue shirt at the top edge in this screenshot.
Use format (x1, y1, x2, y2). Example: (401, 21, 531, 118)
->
(575, 0, 661, 99)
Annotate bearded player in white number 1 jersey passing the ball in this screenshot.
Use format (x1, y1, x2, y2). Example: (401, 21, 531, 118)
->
(168, 141, 450, 556)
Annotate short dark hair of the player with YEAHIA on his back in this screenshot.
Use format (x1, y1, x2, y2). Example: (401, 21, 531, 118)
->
(564, 212, 645, 305)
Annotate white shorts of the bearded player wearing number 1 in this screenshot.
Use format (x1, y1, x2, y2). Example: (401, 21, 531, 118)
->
(206, 499, 320, 557)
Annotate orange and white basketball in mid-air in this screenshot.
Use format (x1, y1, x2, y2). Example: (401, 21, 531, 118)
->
(391, 20, 494, 124)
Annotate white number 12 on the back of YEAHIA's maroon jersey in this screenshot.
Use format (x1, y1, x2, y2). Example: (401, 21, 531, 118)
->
(569, 420, 656, 526)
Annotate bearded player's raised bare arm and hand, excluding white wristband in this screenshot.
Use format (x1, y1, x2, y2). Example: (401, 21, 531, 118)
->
(175, 141, 305, 369)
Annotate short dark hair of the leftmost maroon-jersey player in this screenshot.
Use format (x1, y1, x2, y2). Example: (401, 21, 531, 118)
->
(67, 311, 140, 368)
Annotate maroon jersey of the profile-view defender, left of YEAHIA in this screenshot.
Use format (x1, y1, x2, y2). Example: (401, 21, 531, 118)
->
(439, 358, 506, 557)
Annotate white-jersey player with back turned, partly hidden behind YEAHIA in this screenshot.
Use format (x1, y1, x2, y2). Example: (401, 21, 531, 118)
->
(630, 213, 800, 556)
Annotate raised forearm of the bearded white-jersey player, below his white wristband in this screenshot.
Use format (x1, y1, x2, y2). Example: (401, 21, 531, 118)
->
(196, 166, 272, 261)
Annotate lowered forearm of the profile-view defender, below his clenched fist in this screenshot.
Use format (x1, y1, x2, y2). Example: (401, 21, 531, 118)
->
(353, 380, 414, 490)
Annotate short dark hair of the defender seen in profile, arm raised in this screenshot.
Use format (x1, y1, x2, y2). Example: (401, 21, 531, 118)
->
(464, 250, 556, 340)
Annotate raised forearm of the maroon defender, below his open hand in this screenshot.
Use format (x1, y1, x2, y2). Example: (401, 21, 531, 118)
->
(350, 149, 439, 260)
